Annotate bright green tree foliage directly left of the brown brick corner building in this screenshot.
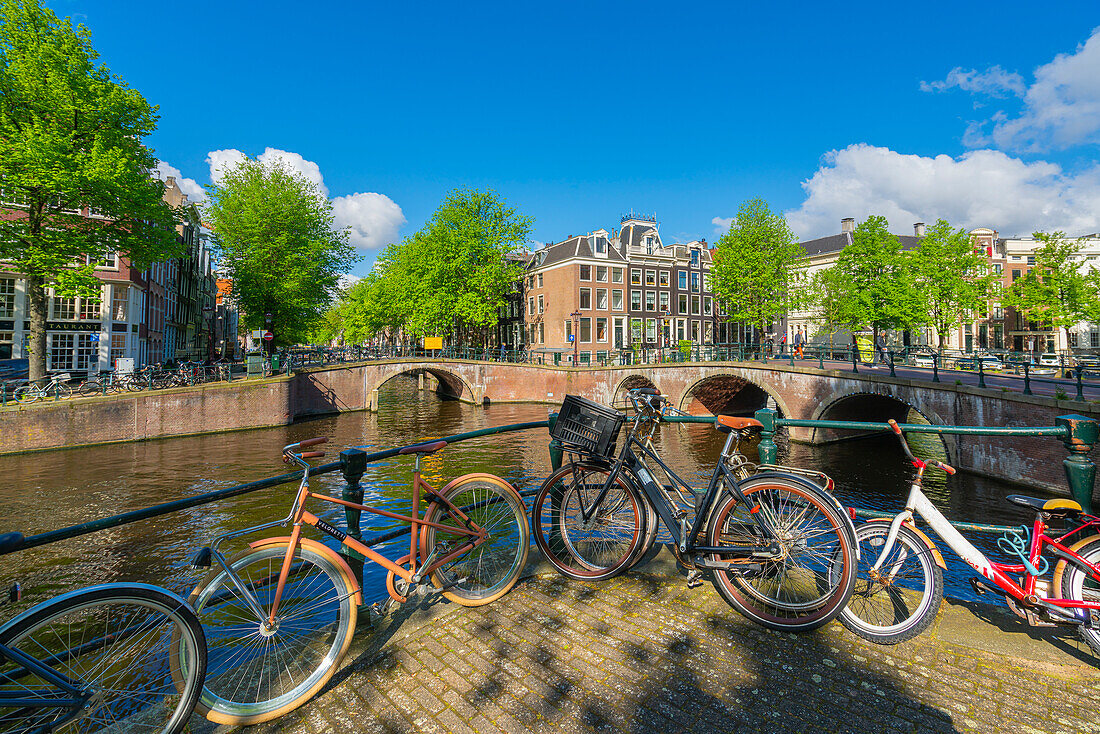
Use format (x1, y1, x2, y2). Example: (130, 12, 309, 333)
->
(343, 189, 534, 342)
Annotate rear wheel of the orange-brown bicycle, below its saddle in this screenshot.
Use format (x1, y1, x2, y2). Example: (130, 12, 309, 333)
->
(420, 479, 531, 606)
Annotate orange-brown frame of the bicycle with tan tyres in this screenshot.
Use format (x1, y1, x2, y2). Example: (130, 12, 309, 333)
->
(210, 454, 488, 625)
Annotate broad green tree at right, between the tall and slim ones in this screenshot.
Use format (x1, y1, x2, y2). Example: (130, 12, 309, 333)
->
(820, 216, 921, 340)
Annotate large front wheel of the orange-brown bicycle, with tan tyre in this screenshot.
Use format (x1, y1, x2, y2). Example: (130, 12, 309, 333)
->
(188, 543, 356, 724)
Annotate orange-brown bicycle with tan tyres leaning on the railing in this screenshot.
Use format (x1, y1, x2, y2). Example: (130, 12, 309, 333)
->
(181, 438, 530, 724)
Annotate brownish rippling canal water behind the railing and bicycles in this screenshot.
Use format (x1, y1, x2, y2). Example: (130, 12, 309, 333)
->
(0, 377, 1064, 620)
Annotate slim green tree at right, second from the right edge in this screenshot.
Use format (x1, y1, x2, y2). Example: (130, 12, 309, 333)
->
(913, 219, 998, 349)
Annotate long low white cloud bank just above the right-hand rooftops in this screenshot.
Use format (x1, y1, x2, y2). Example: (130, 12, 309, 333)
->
(787, 143, 1100, 239)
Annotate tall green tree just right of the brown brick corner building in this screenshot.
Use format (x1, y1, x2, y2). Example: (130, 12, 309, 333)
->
(711, 199, 806, 341)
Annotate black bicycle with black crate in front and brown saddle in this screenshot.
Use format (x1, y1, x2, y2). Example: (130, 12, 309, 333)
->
(531, 388, 858, 631)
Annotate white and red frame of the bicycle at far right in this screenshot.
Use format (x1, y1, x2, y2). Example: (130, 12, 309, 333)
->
(872, 479, 1100, 610)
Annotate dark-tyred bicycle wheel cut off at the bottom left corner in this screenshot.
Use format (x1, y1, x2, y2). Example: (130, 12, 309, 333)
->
(0, 583, 207, 734)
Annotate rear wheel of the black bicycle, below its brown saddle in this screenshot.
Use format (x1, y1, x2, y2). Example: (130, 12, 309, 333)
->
(707, 476, 856, 631)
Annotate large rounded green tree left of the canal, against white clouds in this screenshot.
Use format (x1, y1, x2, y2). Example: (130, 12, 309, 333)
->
(204, 158, 359, 344)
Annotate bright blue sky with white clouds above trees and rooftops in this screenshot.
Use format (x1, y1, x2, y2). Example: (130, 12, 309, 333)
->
(58, 0, 1100, 274)
